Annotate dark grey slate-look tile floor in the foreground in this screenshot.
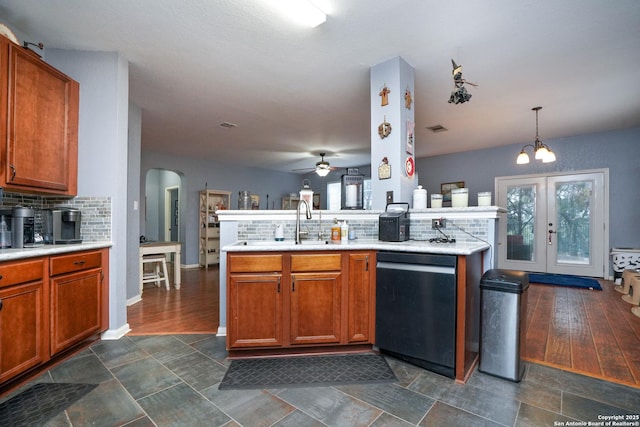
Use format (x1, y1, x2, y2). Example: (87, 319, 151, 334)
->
(0, 335, 640, 427)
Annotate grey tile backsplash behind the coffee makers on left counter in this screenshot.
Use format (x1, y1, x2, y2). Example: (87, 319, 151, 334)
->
(0, 192, 111, 242)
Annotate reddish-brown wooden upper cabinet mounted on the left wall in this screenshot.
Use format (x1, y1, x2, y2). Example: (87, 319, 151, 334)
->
(0, 36, 80, 196)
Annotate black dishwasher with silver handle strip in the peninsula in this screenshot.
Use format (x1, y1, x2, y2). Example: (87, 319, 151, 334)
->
(376, 252, 457, 378)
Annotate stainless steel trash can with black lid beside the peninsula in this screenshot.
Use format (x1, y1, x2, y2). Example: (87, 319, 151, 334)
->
(478, 269, 529, 382)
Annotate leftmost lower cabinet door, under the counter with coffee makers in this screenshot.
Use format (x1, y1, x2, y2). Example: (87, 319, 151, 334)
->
(0, 281, 49, 383)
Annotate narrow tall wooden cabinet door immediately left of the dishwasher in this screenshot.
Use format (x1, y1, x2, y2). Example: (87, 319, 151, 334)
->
(347, 252, 376, 343)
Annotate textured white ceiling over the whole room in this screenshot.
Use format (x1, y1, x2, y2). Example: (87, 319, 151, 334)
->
(0, 0, 640, 171)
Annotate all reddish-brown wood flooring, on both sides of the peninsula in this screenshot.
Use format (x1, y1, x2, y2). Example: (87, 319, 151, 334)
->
(127, 267, 640, 388)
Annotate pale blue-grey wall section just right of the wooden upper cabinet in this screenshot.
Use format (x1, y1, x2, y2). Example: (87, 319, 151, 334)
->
(46, 49, 131, 335)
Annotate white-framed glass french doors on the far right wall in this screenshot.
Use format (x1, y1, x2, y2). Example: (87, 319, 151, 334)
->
(496, 170, 609, 277)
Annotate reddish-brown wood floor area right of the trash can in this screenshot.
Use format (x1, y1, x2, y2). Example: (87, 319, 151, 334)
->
(523, 280, 640, 387)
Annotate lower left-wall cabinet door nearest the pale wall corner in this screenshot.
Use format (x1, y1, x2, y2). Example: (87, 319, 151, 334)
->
(50, 269, 103, 355)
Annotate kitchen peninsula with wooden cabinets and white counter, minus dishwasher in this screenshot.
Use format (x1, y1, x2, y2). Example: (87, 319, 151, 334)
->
(218, 207, 504, 383)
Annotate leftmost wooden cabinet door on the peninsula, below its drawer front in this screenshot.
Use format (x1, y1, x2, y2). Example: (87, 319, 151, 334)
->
(227, 273, 283, 349)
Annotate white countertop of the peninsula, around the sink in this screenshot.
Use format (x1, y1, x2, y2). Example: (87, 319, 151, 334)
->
(222, 239, 490, 255)
